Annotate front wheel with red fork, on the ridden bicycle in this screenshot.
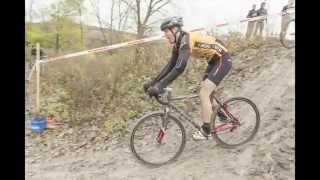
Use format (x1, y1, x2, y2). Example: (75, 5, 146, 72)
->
(130, 112, 186, 166)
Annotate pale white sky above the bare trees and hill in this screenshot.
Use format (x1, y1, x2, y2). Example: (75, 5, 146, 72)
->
(25, 0, 288, 34)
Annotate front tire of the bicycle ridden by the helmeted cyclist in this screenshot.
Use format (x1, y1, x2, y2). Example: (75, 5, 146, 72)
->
(130, 111, 186, 166)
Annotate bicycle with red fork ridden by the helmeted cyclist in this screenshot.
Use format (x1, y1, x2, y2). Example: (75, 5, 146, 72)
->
(130, 88, 260, 166)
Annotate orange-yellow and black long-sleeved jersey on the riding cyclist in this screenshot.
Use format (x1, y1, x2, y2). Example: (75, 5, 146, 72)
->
(154, 31, 228, 86)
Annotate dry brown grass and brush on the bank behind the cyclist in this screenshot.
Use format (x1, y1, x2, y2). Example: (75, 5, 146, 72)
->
(27, 33, 266, 133)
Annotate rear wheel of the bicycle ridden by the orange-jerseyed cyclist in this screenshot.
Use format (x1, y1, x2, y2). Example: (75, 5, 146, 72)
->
(213, 97, 260, 148)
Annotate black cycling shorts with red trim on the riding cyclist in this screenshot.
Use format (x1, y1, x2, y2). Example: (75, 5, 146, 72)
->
(202, 53, 232, 86)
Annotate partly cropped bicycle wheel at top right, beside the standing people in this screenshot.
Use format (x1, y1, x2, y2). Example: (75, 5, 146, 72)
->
(280, 20, 295, 49)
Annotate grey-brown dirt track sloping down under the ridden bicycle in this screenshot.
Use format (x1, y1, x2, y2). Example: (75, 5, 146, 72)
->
(26, 42, 295, 180)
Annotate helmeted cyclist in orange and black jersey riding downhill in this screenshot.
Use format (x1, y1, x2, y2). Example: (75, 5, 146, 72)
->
(144, 17, 232, 140)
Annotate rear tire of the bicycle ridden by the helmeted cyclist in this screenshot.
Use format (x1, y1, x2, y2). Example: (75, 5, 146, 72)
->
(213, 97, 260, 148)
